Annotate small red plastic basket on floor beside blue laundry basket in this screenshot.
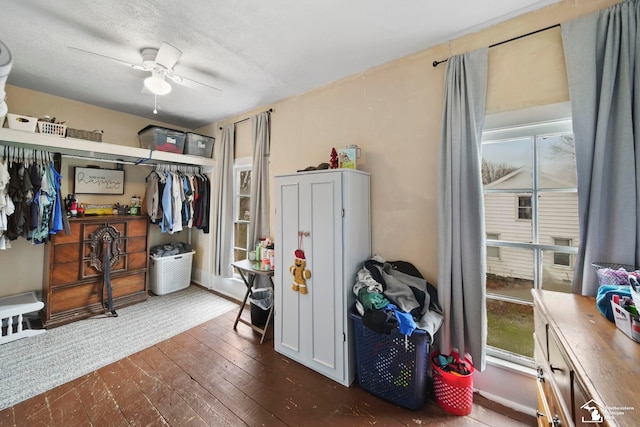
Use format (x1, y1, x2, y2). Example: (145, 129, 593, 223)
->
(431, 351, 474, 416)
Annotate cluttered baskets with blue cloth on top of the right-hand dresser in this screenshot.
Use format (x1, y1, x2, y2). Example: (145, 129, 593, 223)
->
(591, 262, 640, 342)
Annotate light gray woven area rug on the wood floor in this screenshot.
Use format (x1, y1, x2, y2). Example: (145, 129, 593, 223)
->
(0, 285, 238, 410)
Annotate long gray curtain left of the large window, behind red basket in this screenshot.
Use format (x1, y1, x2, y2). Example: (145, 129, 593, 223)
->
(438, 48, 488, 371)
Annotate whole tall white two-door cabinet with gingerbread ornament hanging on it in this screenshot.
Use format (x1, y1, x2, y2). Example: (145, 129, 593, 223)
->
(274, 169, 371, 386)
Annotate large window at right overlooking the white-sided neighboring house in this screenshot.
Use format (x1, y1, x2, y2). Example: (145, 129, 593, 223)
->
(482, 116, 579, 365)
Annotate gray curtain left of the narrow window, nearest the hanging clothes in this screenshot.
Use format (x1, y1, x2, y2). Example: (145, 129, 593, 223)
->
(212, 124, 235, 277)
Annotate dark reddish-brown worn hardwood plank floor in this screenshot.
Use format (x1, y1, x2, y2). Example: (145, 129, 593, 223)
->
(0, 298, 535, 427)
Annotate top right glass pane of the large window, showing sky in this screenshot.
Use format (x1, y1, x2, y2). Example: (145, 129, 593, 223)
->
(538, 135, 577, 188)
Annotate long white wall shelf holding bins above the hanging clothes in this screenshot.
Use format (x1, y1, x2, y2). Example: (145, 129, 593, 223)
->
(0, 128, 214, 172)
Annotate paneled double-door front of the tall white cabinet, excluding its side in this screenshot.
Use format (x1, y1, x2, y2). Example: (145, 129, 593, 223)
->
(275, 172, 345, 381)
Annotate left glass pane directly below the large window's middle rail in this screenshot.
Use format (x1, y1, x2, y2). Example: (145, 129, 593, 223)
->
(487, 247, 533, 301)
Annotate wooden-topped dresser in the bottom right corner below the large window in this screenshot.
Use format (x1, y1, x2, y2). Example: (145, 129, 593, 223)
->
(533, 290, 640, 426)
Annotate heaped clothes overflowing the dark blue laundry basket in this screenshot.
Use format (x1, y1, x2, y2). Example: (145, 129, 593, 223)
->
(353, 255, 443, 343)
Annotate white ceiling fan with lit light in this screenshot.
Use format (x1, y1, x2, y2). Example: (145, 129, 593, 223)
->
(69, 43, 221, 104)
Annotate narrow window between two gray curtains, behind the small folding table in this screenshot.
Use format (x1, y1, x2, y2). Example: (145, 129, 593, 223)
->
(233, 162, 251, 261)
